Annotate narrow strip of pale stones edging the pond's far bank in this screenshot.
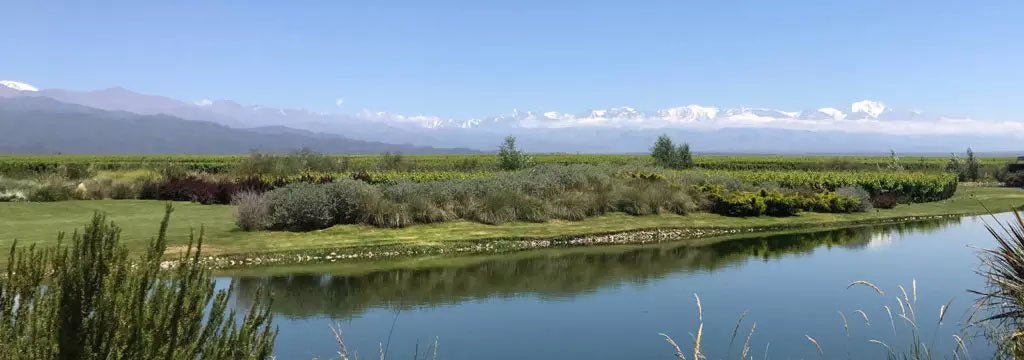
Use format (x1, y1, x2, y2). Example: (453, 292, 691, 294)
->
(161, 214, 970, 269)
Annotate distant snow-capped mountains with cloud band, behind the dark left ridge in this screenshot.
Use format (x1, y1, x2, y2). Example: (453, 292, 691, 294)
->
(0, 81, 1024, 152)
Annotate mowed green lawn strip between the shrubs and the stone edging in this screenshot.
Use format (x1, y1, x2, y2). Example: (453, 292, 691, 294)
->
(0, 186, 1024, 258)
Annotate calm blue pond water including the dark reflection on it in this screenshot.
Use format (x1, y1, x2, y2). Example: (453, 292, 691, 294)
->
(220, 215, 1009, 359)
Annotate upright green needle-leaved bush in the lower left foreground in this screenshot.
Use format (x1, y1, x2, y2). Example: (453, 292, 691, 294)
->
(0, 207, 276, 359)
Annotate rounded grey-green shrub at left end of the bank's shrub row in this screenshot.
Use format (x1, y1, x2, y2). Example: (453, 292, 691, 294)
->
(264, 183, 337, 231)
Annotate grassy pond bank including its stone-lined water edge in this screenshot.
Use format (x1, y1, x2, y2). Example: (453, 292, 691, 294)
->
(0, 184, 1024, 270)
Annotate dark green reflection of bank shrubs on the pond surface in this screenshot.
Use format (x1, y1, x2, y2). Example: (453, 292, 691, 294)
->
(234, 219, 959, 317)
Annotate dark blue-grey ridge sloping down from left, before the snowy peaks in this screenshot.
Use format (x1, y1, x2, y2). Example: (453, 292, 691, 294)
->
(0, 96, 472, 153)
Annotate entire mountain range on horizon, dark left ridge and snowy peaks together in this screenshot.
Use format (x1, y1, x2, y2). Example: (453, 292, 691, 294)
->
(0, 81, 1024, 153)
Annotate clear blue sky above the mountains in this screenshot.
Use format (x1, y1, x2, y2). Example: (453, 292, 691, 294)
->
(8, 0, 1024, 120)
